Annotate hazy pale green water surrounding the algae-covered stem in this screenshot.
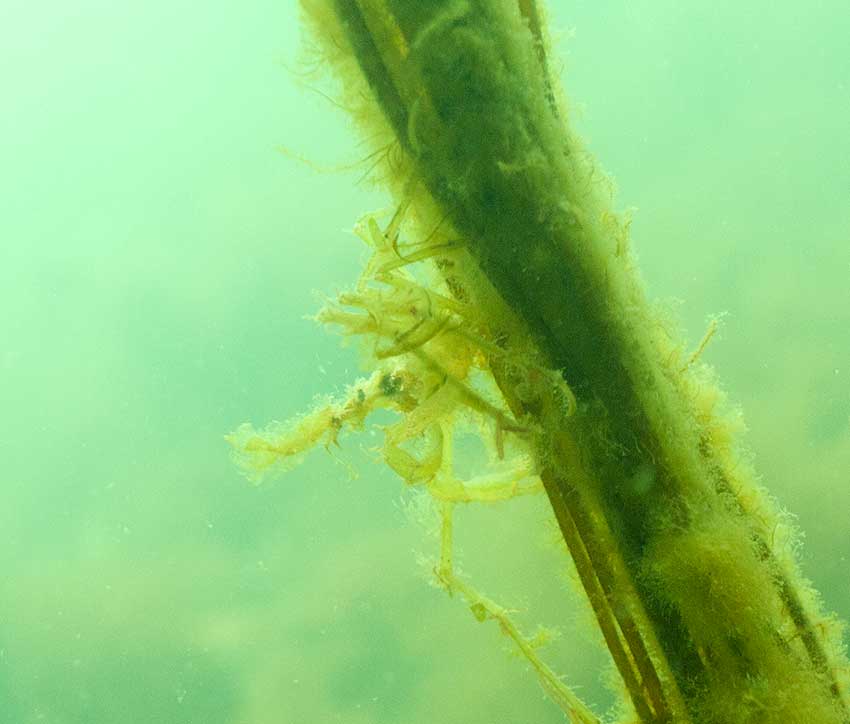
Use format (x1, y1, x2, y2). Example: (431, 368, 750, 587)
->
(0, 0, 850, 724)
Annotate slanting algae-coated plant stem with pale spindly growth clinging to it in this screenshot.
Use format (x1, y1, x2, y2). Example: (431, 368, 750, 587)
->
(230, 0, 850, 724)
